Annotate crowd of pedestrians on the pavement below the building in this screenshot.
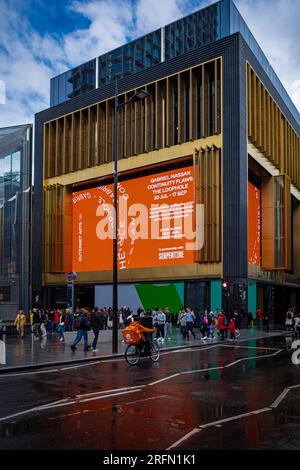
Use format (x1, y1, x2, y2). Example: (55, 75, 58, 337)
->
(9, 305, 300, 351)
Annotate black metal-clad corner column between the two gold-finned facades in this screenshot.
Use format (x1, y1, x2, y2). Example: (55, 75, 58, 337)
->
(223, 35, 248, 279)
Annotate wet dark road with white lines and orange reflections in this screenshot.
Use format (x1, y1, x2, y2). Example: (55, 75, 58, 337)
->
(0, 337, 300, 450)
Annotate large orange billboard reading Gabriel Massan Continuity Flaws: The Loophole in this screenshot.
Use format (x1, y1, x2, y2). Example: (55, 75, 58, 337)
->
(72, 166, 195, 272)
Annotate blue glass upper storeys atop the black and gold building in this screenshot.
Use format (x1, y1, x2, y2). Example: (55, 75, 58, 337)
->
(50, 0, 300, 124)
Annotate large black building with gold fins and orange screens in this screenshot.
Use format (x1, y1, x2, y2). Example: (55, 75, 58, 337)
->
(33, 0, 300, 321)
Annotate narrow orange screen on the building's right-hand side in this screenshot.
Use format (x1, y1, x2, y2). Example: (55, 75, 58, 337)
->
(248, 182, 261, 266)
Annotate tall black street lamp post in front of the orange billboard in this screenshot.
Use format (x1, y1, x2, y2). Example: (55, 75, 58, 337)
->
(112, 83, 150, 354)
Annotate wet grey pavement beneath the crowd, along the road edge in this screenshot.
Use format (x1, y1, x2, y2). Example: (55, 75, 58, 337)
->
(0, 326, 283, 374)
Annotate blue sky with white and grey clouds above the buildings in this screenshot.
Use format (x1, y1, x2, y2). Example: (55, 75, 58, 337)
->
(0, 0, 300, 127)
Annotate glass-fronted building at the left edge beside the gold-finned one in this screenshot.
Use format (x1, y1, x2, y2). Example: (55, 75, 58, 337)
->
(0, 124, 32, 320)
